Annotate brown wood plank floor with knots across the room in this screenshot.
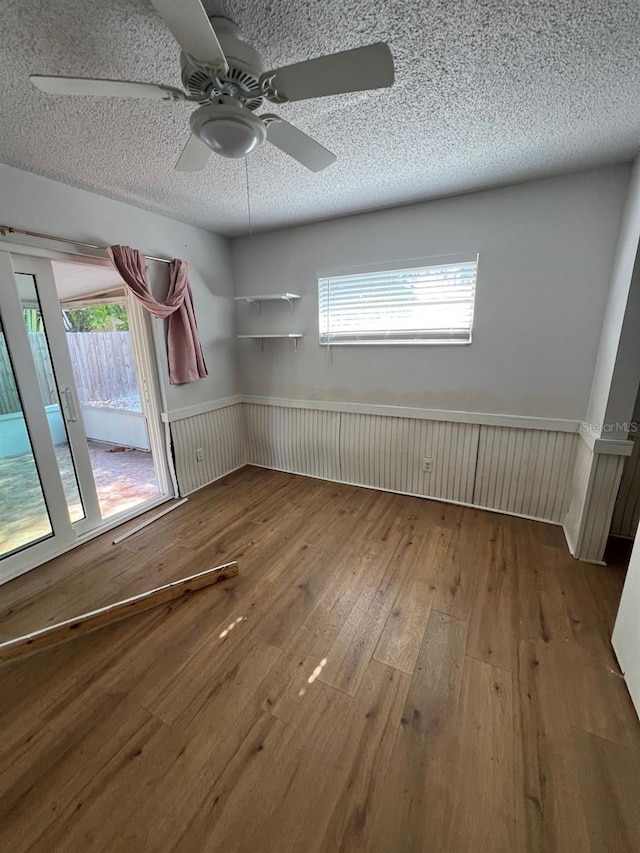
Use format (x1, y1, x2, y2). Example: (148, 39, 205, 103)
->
(0, 468, 640, 853)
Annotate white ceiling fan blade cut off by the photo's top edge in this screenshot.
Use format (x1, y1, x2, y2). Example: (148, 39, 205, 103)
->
(151, 0, 229, 73)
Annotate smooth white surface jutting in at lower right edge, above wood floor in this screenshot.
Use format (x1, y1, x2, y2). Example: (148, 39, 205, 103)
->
(611, 538, 640, 716)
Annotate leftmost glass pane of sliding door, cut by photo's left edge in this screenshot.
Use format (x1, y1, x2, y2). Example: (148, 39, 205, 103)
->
(0, 321, 53, 558)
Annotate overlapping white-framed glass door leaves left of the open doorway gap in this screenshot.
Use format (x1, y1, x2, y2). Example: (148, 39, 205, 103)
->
(0, 252, 102, 582)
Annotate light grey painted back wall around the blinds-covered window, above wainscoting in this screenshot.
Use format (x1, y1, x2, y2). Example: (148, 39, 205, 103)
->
(232, 166, 629, 419)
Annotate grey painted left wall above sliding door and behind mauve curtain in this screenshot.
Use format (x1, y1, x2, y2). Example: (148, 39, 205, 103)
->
(0, 164, 235, 411)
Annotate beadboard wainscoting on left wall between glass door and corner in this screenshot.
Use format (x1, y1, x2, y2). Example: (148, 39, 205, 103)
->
(171, 403, 247, 495)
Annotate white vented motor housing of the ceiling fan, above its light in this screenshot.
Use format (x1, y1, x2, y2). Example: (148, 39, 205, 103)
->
(180, 17, 265, 111)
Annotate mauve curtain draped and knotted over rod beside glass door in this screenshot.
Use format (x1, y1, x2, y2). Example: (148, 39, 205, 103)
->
(107, 246, 207, 385)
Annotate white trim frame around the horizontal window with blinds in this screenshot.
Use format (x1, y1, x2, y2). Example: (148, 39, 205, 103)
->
(316, 252, 480, 347)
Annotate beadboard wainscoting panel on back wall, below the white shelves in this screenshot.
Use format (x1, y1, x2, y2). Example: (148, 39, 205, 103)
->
(244, 403, 340, 480)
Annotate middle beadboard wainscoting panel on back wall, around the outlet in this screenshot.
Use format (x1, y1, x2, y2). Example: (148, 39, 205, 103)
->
(340, 412, 480, 503)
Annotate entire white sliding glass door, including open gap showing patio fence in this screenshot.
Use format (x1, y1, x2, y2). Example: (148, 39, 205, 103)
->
(0, 246, 171, 583)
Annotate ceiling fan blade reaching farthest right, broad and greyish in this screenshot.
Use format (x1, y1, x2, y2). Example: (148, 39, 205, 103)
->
(260, 42, 395, 103)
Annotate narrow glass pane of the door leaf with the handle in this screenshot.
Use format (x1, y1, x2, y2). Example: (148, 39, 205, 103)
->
(15, 273, 85, 522)
